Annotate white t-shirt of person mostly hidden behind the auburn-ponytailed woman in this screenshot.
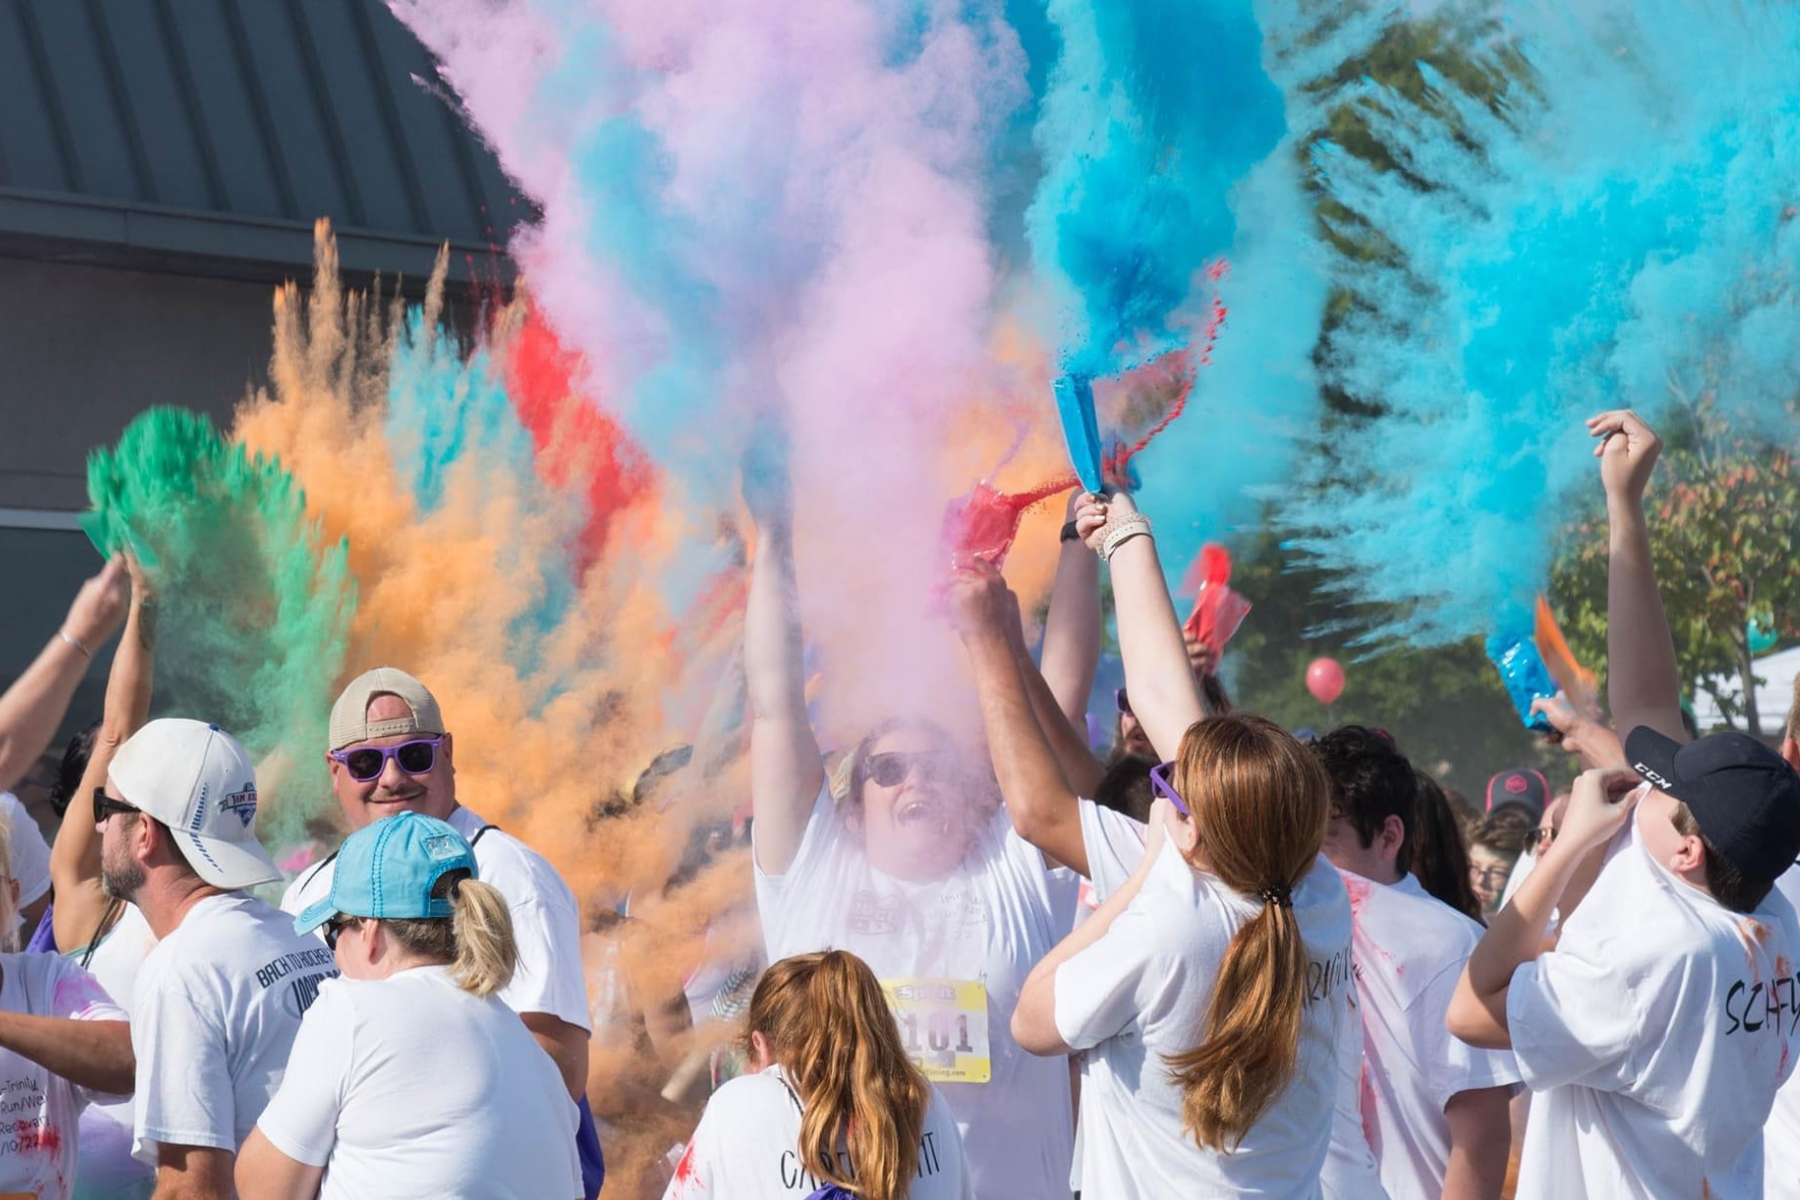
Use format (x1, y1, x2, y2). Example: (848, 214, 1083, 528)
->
(1076, 801, 1388, 1200)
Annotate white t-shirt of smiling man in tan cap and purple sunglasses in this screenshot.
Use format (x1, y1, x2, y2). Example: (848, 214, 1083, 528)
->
(281, 806, 589, 1029)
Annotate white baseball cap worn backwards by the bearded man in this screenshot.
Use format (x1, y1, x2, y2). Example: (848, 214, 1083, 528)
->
(106, 718, 281, 889)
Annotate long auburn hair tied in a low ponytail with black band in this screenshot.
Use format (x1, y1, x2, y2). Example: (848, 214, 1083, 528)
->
(1168, 714, 1332, 1151)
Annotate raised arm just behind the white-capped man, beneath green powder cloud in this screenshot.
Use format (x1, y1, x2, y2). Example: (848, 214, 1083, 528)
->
(50, 560, 157, 950)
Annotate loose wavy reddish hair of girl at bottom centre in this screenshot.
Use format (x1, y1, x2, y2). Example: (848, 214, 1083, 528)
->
(745, 950, 931, 1200)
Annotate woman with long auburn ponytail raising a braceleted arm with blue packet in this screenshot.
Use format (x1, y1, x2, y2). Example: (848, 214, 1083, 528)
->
(1000, 495, 1355, 1200)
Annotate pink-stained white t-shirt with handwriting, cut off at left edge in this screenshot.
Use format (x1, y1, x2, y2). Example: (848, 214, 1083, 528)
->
(0, 954, 126, 1200)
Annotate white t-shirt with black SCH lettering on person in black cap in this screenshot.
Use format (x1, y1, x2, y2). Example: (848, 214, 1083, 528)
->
(1507, 808, 1800, 1200)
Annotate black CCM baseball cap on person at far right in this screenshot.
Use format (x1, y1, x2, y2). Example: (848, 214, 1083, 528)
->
(1625, 725, 1800, 883)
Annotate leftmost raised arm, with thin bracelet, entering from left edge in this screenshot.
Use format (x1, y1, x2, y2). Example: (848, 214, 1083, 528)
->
(0, 558, 126, 790)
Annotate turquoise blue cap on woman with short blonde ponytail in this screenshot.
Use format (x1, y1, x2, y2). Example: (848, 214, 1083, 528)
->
(293, 813, 475, 934)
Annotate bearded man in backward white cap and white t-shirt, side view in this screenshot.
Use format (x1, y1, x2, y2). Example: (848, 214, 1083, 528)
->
(94, 720, 337, 1200)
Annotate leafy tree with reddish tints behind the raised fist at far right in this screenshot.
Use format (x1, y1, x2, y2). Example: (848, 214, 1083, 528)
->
(1552, 392, 1800, 736)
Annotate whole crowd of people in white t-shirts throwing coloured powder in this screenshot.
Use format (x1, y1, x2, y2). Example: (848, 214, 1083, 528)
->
(0, 412, 1800, 1200)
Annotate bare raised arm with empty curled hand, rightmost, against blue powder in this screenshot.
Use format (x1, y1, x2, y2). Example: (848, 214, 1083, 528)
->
(1588, 417, 1688, 741)
